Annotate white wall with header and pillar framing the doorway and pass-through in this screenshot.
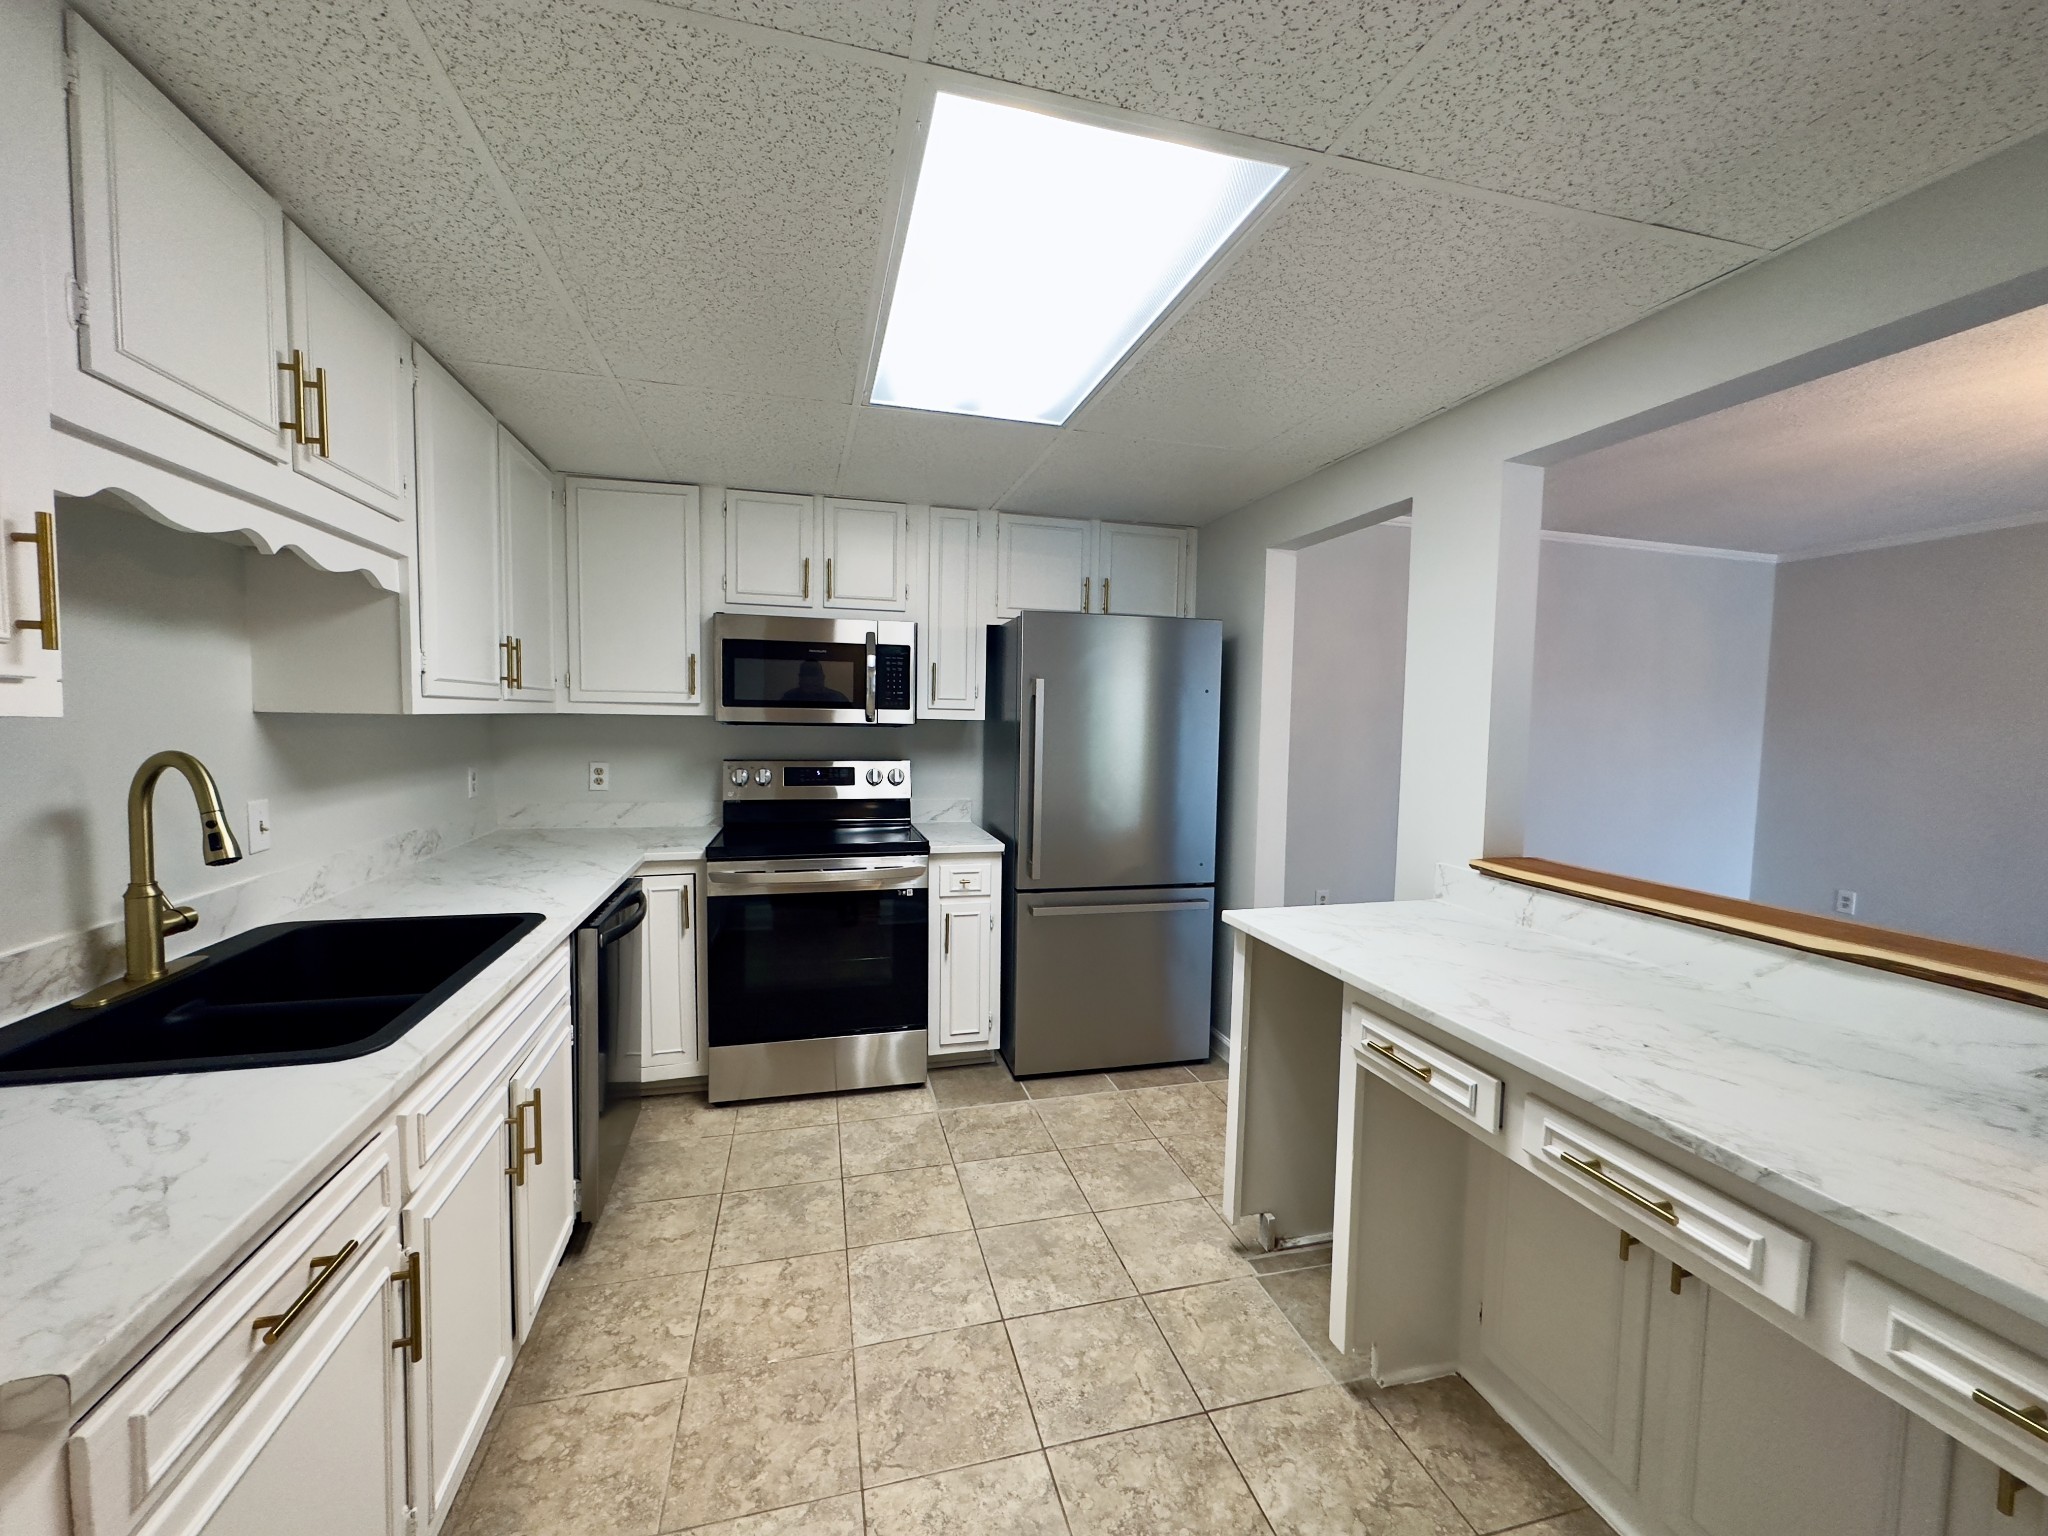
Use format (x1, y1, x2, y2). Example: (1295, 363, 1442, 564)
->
(1200, 137, 2048, 987)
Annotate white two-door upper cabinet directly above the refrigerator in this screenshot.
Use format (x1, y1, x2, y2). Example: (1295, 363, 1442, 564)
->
(995, 512, 1194, 618)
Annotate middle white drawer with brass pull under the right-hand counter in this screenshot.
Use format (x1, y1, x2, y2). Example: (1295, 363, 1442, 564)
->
(1522, 1100, 1812, 1317)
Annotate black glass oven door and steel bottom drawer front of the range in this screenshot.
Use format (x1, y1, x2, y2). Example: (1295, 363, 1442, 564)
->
(705, 854, 932, 1102)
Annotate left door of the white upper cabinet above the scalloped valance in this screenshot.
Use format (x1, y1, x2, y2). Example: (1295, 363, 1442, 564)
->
(66, 14, 291, 461)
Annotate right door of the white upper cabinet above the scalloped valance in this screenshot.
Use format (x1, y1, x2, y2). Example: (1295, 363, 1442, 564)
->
(285, 225, 412, 522)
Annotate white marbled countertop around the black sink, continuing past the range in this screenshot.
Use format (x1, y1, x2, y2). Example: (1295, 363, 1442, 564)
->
(0, 821, 983, 1430)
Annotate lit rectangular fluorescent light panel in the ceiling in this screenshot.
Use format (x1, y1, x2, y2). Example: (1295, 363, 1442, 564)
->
(868, 92, 1286, 426)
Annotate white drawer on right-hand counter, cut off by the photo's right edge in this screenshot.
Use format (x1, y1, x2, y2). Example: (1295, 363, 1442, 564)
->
(1841, 1264, 2048, 1487)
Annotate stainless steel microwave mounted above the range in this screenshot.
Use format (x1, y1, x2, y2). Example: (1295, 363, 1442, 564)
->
(711, 612, 918, 725)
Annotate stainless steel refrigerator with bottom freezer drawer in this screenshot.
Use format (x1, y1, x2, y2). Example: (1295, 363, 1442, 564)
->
(983, 612, 1223, 1075)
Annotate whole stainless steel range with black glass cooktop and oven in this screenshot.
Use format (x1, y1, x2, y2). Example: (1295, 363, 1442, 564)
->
(705, 760, 932, 1104)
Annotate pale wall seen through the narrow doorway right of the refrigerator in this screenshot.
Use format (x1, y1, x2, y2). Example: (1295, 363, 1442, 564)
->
(1286, 522, 1409, 905)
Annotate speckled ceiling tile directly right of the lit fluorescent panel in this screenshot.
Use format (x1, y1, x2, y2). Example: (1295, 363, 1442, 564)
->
(1077, 172, 1735, 449)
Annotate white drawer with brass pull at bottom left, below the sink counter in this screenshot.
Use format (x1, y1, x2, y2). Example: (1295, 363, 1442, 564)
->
(70, 1128, 397, 1536)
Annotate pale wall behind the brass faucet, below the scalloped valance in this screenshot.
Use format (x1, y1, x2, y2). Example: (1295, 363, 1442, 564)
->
(0, 502, 494, 954)
